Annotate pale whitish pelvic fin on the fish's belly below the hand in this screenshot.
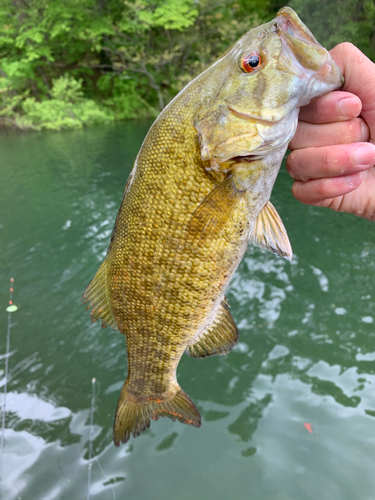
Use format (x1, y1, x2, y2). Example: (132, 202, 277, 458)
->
(250, 201, 293, 262)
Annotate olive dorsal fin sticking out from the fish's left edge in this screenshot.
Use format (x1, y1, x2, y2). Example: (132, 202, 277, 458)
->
(82, 259, 118, 330)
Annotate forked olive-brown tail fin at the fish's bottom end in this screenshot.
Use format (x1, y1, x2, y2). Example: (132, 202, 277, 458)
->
(113, 382, 201, 446)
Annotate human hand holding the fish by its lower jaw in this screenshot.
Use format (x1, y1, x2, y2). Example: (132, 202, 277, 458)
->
(287, 43, 375, 221)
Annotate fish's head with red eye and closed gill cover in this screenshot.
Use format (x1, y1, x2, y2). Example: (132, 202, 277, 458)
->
(195, 7, 344, 165)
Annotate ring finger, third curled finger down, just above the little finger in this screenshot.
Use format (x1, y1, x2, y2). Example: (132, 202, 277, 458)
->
(286, 142, 375, 182)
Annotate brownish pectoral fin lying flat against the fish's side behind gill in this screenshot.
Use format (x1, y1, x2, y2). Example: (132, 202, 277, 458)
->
(187, 175, 244, 240)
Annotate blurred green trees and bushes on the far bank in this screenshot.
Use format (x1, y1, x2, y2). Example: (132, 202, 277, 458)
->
(0, 0, 375, 130)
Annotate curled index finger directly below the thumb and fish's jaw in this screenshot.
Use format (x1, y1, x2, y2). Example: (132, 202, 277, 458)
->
(299, 91, 362, 123)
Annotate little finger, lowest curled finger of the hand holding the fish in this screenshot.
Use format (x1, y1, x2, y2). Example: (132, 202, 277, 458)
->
(292, 172, 363, 205)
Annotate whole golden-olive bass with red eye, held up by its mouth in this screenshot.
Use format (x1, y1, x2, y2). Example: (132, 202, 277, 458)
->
(82, 7, 343, 446)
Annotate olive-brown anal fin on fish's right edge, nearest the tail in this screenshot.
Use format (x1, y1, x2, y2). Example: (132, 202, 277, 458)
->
(185, 298, 238, 358)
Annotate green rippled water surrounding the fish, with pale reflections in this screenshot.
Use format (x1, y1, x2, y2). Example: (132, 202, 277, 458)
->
(0, 123, 375, 500)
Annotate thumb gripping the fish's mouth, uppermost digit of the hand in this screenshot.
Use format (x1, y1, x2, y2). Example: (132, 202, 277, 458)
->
(330, 42, 375, 142)
